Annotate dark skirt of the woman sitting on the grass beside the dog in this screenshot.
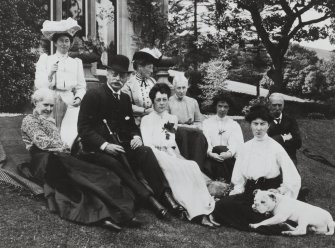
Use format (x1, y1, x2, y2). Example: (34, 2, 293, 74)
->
(213, 176, 286, 235)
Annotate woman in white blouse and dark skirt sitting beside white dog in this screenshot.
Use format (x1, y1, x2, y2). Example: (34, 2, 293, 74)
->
(213, 105, 301, 234)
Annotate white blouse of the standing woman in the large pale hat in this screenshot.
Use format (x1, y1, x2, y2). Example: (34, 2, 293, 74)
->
(35, 52, 86, 104)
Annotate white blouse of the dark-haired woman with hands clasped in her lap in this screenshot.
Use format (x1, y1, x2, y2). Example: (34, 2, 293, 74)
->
(202, 115, 244, 156)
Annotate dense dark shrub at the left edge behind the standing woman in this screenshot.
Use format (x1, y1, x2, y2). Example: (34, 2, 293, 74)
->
(0, 0, 46, 112)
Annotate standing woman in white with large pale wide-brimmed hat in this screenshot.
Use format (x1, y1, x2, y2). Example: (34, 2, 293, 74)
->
(35, 18, 86, 147)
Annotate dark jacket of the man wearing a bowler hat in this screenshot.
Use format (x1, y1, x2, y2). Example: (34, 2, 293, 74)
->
(78, 84, 140, 151)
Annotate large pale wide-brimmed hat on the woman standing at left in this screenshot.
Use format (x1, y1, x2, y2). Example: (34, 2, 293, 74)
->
(41, 17, 81, 40)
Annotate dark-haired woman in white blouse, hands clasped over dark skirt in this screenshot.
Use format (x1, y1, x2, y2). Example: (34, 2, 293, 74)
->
(203, 93, 244, 182)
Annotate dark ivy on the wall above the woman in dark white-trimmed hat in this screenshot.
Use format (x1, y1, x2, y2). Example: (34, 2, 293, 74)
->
(127, 0, 169, 47)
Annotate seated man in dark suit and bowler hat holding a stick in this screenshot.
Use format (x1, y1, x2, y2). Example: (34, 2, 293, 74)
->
(78, 55, 181, 223)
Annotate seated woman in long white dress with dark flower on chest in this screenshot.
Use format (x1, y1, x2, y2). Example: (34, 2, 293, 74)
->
(141, 83, 215, 226)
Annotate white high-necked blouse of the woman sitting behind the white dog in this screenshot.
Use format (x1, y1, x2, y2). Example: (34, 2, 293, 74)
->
(230, 134, 301, 198)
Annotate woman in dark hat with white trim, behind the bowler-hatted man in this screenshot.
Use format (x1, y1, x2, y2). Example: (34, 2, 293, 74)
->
(122, 48, 162, 125)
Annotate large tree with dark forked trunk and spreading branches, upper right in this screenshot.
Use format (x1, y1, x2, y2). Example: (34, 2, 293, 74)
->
(215, 0, 335, 92)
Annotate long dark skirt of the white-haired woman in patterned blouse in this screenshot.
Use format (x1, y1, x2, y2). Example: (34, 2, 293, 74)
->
(19, 147, 135, 224)
